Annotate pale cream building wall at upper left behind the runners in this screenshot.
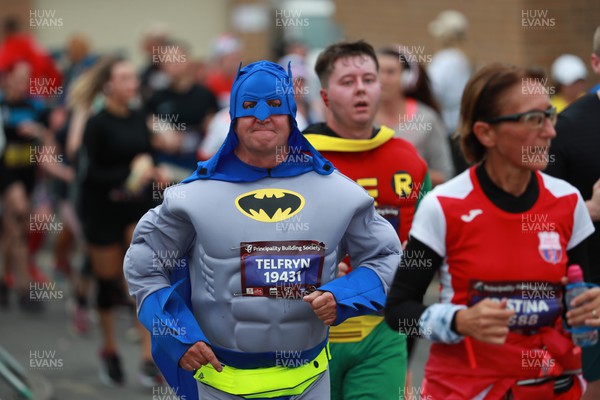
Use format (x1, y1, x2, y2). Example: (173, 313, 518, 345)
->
(0, 0, 227, 65)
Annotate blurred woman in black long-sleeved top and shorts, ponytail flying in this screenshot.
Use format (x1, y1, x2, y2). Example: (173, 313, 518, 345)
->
(81, 55, 166, 386)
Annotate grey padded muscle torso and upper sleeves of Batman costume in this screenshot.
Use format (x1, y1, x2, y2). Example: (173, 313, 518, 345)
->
(125, 171, 399, 352)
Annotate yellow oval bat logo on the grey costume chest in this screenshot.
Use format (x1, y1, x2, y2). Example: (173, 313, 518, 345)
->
(235, 189, 304, 222)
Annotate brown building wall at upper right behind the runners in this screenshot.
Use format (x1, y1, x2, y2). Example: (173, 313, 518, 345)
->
(335, 0, 600, 80)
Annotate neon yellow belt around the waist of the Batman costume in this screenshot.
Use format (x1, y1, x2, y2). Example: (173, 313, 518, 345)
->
(194, 344, 331, 399)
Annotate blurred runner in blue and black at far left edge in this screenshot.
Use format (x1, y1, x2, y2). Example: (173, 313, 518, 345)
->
(0, 62, 46, 311)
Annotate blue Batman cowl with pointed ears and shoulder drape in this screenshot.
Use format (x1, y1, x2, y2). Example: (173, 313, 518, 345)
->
(183, 61, 334, 183)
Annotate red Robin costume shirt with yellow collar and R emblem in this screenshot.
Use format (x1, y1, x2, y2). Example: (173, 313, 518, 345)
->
(303, 123, 431, 242)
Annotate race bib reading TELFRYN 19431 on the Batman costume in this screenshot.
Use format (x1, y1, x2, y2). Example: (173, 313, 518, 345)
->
(241, 240, 325, 300)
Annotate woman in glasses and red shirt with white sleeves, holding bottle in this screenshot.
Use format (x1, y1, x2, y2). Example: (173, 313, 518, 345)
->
(386, 64, 600, 400)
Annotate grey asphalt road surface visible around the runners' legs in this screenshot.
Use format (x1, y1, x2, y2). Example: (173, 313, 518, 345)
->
(0, 250, 437, 400)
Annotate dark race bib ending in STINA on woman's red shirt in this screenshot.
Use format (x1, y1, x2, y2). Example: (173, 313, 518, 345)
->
(467, 280, 562, 334)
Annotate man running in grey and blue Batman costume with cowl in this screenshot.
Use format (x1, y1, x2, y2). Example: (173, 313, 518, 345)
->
(124, 61, 401, 400)
